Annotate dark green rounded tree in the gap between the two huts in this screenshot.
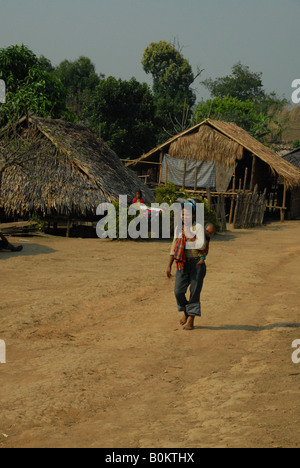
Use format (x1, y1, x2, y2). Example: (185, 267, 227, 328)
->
(88, 77, 156, 159)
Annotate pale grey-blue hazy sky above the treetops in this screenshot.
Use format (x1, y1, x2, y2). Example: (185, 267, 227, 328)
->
(0, 0, 300, 102)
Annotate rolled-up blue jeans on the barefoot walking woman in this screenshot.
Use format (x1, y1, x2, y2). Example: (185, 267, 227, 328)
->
(175, 258, 206, 317)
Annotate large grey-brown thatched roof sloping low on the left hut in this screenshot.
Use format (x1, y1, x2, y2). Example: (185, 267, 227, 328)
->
(0, 117, 153, 217)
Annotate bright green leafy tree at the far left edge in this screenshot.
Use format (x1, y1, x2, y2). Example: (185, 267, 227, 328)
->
(0, 45, 66, 126)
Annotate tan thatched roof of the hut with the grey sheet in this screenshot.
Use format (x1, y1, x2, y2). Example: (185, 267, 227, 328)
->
(127, 119, 300, 187)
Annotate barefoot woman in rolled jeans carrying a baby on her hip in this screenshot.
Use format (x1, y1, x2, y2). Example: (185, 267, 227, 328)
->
(167, 201, 216, 330)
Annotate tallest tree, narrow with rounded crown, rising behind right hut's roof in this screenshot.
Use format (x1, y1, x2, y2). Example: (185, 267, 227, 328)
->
(142, 41, 196, 140)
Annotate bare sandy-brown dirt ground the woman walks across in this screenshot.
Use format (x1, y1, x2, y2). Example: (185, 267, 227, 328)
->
(0, 221, 300, 448)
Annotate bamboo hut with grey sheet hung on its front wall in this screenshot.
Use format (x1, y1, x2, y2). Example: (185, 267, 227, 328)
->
(127, 119, 300, 224)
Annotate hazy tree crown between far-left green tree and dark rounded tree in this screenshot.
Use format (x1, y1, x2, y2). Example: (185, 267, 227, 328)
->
(55, 57, 103, 119)
